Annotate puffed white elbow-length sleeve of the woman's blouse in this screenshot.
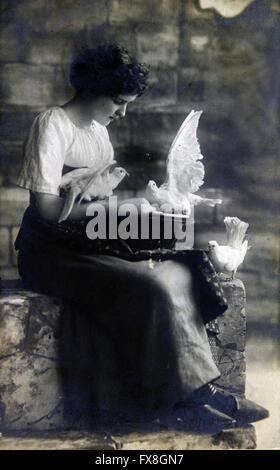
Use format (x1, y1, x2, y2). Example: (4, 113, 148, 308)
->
(17, 108, 73, 195)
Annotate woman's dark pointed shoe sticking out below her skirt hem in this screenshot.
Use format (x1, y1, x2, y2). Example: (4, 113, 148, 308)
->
(186, 384, 269, 425)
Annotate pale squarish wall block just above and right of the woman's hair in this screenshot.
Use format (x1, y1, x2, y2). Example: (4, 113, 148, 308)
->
(136, 24, 179, 67)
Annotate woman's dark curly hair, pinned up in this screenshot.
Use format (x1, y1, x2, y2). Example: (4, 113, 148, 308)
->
(69, 44, 149, 96)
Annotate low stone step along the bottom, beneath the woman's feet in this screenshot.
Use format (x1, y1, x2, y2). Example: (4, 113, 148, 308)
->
(0, 425, 256, 452)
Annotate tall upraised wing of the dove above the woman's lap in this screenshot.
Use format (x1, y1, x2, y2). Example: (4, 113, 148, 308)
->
(165, 111, 203, 194)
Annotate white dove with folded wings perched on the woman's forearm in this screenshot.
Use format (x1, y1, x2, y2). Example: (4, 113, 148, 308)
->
(58, 160, 128, 223)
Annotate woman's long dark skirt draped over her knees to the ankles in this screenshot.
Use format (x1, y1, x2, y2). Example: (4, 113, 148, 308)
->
(17, 207, 225, 419)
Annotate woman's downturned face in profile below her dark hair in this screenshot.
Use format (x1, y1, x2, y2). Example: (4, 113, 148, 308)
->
(88, 95, 137, 126)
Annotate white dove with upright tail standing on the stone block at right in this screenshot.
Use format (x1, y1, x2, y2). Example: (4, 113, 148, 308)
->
(208, 217, 249, 280)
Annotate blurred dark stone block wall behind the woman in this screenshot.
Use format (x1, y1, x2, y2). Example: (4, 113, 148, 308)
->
(0, 0, 280, 274)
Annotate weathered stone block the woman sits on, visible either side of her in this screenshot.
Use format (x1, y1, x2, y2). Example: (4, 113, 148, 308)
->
(0, 280, 248, 434)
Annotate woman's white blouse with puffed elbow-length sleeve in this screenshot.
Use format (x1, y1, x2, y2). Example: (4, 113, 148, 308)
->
(17, 106, 114, 196)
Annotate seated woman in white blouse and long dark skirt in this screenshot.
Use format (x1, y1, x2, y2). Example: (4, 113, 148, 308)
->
(15, 45, 267, 428)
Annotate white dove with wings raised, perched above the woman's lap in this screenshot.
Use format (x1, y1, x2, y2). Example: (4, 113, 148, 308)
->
(146, 111, 222, 216)
